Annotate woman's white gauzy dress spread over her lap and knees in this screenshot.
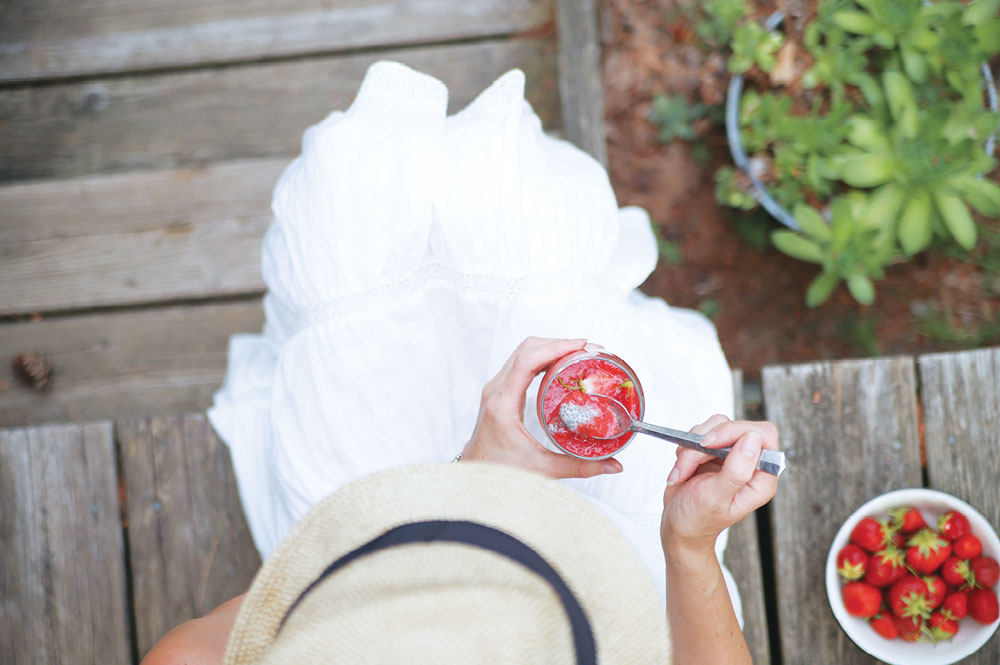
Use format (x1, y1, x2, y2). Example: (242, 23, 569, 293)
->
(208, 62, 739, 624)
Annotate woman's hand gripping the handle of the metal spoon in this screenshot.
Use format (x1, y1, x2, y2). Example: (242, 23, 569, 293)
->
(660, 415, 778, 552)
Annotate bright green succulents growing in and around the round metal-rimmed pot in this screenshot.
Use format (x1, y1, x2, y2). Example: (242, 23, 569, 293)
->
(716, 0, 1000, 305)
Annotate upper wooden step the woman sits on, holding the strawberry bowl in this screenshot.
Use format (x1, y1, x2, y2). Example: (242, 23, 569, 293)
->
(0, 348, 1000, 665)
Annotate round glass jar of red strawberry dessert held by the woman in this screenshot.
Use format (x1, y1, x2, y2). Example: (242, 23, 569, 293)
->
(535, 344, 646, 459)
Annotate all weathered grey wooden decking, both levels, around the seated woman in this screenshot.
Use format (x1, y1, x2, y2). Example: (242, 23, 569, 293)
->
(0, 0, 1000, 665)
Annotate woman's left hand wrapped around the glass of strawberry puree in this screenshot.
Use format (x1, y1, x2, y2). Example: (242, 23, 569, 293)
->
(462, 337, 622, 478)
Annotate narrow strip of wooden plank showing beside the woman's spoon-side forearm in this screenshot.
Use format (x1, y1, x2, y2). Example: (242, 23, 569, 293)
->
(723, 369, 771, 663)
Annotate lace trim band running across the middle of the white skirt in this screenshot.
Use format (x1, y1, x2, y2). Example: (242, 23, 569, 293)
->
(288, 263, 619, 338)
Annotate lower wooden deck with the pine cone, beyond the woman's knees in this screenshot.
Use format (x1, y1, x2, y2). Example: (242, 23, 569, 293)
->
(0, 0, 604, 425)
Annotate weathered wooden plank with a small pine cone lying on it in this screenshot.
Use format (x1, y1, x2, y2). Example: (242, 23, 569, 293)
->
(0, 300, 264, 425)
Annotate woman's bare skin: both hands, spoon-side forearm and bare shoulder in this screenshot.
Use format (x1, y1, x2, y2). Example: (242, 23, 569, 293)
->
(143, 338, 778, 665)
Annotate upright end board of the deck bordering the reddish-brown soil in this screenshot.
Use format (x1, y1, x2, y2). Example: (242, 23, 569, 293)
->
(556, 0, 608, 166)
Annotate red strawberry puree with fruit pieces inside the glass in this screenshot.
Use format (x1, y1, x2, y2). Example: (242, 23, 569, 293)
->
(542, 358, 639, 457)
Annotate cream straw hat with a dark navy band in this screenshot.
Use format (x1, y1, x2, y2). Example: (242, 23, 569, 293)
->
(225, 462, 670, 665)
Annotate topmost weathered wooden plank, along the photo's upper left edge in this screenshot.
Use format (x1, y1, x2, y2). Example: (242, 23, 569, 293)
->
(0, 0, 552, 80)
